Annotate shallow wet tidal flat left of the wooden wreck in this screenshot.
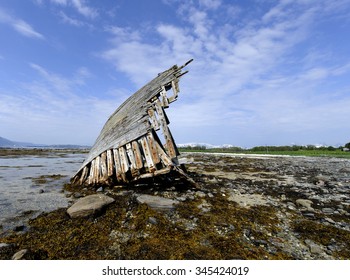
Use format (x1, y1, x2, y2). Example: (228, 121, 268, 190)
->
(0, 149, 85, 232)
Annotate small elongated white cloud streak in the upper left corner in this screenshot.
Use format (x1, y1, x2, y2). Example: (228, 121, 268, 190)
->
(0, 9, 45, 39)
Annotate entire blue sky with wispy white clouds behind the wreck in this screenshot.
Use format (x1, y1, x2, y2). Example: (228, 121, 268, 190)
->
(0, 0, 350, 147)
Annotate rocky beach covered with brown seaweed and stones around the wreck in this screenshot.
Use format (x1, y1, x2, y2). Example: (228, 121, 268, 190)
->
(0, 153, 350, 260)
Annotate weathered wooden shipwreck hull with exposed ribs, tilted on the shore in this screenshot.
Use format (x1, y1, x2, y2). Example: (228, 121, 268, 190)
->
(72, 60, 195, 186)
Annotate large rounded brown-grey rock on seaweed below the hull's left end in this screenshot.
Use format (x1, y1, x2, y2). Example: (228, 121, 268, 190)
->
(67, 194, 114, 218)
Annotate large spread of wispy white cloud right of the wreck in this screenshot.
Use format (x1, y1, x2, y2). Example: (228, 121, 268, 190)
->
(101, 0, 350, 145)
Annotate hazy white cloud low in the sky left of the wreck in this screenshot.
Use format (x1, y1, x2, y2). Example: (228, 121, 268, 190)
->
(0, 63, 117, 145)
